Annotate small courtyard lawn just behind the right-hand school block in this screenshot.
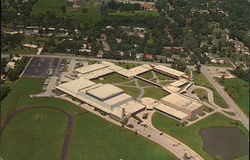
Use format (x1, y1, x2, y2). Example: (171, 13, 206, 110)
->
(143, 87, 168, 100)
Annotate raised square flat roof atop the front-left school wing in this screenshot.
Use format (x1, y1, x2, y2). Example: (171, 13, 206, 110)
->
(86, 84, 124, 99)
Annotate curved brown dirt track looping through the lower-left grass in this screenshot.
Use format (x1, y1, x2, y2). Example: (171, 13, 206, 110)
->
(0, 106, 74, 160)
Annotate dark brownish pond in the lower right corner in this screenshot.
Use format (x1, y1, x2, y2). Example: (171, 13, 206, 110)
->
(200, 127, 249, 160)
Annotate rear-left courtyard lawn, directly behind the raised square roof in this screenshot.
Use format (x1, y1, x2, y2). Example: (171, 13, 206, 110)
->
(93, 73, 130, 83)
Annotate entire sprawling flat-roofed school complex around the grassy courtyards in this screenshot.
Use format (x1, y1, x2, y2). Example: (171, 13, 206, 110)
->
(55, 61, 203, 121)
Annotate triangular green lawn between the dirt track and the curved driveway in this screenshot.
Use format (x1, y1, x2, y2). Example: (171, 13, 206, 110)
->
(70, 114, 177, 160)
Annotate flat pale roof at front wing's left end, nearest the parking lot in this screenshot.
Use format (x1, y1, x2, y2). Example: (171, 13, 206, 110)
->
(56, 78, 95, 94)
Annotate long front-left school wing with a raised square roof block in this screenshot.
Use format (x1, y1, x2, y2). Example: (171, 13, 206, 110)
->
(56, 78, 145, 120)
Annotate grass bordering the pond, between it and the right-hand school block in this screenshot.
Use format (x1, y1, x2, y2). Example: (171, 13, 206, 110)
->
(152, 113, 248, 160)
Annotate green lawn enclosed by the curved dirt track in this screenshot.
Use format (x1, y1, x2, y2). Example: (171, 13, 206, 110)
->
(0, 109, 67, 160)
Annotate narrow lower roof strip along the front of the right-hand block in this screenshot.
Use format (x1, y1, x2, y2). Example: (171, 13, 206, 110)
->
(154, 103, 188, 119)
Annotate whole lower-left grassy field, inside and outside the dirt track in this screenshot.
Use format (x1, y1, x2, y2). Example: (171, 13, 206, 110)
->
(0, 78, 180, 160)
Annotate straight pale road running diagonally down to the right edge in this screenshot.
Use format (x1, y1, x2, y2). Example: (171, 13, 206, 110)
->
(201, 66, 249, 130)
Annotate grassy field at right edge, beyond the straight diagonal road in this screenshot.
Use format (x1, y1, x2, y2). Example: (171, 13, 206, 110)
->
(216, 78, 249, 116)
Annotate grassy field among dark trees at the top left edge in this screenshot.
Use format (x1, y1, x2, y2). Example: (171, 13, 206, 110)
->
(32, 0, 101, 22)
